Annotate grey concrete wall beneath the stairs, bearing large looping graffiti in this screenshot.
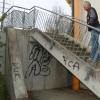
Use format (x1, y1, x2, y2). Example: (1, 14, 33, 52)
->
(17, 30, 67, 90)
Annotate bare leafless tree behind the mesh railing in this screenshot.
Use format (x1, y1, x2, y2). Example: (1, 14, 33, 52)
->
(46, 7, 63, 33)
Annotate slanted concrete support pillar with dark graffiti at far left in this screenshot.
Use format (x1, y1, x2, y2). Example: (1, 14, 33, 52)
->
(6, 28, 28, 100)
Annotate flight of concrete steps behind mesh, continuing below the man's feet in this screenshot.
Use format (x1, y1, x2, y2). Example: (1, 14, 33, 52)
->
(47, 33, 100, 70)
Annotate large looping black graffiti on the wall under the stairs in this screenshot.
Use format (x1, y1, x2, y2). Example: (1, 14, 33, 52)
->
(25, 41, 52, 78)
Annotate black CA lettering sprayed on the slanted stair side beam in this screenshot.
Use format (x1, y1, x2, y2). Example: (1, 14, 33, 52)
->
(63, 56, 80, 70)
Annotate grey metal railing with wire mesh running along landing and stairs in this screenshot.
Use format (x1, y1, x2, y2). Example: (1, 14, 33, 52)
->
(4, 6, 100, 61)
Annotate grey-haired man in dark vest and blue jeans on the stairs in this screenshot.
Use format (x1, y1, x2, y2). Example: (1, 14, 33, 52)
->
(84, 1, 100, 62)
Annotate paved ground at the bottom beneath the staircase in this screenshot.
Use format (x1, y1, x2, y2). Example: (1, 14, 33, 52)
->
(33, 89, 100, 100)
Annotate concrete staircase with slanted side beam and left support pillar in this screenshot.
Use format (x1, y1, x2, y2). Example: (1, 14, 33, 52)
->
(6, 28, 100, 100)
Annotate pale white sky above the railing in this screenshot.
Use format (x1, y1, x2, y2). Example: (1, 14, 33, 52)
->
(0, 0, 71, 15)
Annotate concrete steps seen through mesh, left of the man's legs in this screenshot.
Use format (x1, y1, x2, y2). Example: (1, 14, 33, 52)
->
(47, 33, 90, 61)
